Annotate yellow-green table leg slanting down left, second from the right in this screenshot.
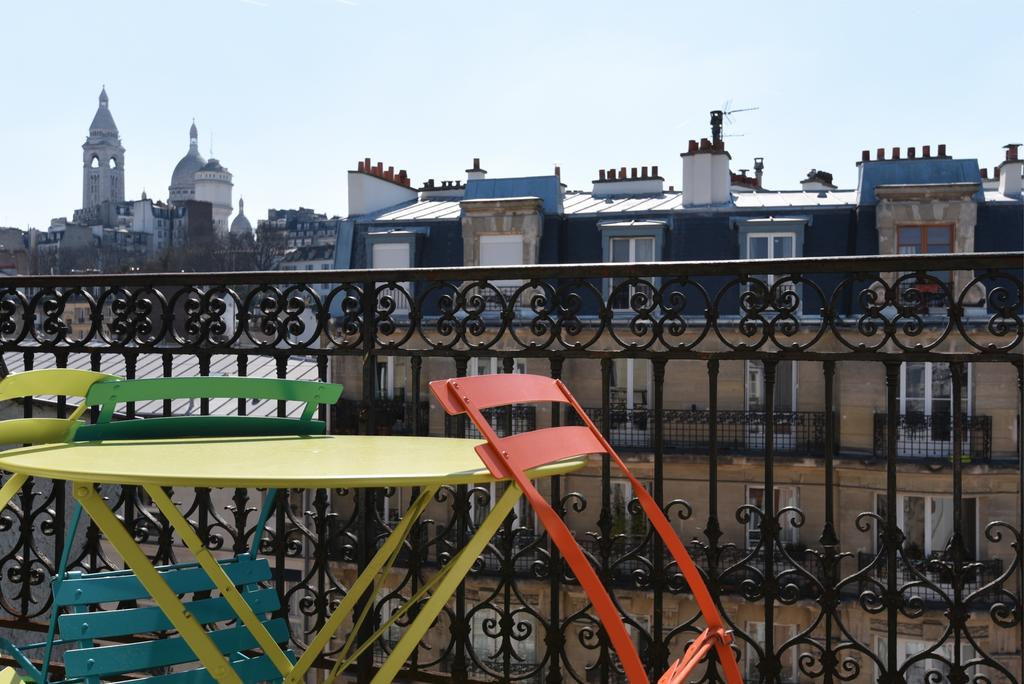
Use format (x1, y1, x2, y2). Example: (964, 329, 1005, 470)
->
(285, 486, 437, 684)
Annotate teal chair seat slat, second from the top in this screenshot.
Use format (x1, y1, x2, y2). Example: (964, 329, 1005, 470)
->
(58, 589, 281, 641)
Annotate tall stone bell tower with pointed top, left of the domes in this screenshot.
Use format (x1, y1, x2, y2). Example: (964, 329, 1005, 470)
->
(82, 86, 125, 211)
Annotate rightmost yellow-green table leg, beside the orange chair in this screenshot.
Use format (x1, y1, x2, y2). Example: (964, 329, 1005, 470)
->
(372, 482, 522, 684)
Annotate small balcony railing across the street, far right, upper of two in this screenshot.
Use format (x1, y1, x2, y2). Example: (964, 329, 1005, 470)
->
(873, 414, 992, 463)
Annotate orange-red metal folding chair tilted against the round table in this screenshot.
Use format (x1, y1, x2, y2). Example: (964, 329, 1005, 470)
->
(430, 374, 742, 684)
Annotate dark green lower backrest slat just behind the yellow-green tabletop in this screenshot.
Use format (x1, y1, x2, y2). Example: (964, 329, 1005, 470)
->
(72, 416, 327, 441)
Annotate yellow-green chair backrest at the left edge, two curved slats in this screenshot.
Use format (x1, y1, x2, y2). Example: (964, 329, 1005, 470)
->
(0, 369, 118, 444)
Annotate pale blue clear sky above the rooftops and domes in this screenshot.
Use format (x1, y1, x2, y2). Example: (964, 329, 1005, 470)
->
(0, 0, 1024, 228)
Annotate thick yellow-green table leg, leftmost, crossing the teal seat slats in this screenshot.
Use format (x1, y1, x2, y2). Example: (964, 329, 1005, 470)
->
(74, 482, 242, 684)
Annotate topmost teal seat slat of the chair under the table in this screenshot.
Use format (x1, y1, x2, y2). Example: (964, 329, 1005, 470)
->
(53, 556, 271, 606)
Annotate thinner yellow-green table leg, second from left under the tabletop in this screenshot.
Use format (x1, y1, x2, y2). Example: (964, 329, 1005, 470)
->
(145, 484, 292, 675)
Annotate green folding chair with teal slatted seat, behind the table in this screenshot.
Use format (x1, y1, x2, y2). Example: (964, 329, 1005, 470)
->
(0, 376, 342, 684)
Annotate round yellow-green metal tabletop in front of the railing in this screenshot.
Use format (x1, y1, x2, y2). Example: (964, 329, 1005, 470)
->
(0, 435, 586, 488)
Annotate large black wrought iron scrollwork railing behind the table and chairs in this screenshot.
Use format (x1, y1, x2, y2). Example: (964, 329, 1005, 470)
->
(0, 253, 1024, 684)
